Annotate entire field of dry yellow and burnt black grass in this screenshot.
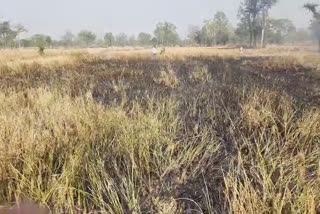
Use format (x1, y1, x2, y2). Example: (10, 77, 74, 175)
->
(0, 46, 320, 214)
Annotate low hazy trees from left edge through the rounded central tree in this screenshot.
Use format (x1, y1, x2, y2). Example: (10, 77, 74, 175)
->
(0, 21, 182, 48)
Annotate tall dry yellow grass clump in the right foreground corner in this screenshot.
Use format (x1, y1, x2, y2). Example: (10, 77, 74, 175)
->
(224, 92, 320, 213)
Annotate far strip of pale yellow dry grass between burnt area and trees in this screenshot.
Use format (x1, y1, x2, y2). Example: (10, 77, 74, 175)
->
(0, 45, 320, 67)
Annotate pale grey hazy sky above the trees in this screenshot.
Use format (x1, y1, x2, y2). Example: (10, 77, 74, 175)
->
(0, 0, 320, 38)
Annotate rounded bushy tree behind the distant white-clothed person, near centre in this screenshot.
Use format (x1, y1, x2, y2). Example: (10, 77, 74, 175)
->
(154, 22, 180, 46)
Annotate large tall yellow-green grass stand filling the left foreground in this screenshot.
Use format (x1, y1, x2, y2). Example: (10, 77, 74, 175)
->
(0, 89, 219, 213)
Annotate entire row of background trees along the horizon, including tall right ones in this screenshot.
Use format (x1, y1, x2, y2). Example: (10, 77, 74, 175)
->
(0, 0, 320, 51)
